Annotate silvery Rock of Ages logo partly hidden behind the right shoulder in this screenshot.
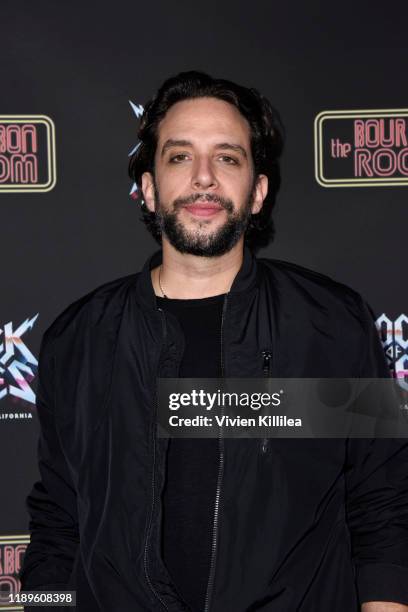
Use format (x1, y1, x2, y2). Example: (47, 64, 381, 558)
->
(376, 313, 408, 391)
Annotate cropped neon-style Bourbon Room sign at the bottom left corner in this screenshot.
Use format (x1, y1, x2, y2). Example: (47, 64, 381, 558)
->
(0, 535, 30, 610)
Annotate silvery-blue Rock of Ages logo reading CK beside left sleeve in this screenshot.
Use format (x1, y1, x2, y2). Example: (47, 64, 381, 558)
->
(0, 313, 38, 412)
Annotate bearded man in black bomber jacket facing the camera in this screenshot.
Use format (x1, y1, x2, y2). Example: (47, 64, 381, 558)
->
(21, 72, 408, 612)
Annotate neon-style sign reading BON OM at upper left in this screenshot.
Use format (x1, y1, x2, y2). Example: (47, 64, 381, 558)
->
(0, 115, 57, 193)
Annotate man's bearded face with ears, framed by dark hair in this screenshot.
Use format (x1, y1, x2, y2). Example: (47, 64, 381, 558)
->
(142, 98, 267, 256)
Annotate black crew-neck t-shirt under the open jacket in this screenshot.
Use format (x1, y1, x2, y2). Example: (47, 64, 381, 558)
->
(157, 295, 224, 612)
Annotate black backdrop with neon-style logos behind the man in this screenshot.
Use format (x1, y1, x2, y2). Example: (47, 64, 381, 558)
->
(0, 0, 408, 600)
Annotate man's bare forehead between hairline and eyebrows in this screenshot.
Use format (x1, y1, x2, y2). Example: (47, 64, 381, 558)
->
(158, 97, 250, 149)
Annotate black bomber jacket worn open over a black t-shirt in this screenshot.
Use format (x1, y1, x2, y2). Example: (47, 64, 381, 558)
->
(21, 248, 408, 612)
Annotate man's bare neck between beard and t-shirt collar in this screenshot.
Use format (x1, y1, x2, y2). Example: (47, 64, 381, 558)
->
(151, 239, 244, 299)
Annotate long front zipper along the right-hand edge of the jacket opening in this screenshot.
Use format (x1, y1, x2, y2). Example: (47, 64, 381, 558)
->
(204, 293, 228, 612)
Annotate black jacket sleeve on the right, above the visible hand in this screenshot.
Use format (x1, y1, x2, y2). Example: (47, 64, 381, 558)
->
(345, 303, 408, 604)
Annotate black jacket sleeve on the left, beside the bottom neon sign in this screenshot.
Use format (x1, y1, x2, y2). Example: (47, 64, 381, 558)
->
(20, 332, 79, 592)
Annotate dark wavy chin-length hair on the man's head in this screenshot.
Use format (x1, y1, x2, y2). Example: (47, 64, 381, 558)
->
(129, 71, 284, 250)
